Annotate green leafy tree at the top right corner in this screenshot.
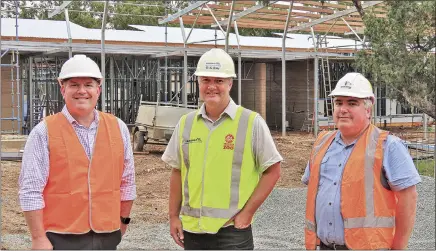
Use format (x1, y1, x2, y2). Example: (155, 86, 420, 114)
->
(356, 0, 436, 118)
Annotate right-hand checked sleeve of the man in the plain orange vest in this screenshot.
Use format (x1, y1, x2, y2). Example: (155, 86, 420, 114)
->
(117, 118, 136, 201)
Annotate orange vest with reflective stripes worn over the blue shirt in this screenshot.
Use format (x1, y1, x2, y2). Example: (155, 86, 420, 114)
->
(304, 125, 396, 250)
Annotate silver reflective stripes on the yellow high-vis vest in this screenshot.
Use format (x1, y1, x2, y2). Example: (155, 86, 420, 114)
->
(181, 108, 251, 218)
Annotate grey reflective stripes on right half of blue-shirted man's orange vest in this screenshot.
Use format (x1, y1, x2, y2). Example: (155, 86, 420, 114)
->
(344, 128, 395, 228)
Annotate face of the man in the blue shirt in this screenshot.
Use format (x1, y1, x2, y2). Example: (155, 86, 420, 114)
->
(333, 97, 371, 134)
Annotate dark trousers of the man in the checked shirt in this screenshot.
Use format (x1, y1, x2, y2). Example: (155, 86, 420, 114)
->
(46, 230, 121, 250)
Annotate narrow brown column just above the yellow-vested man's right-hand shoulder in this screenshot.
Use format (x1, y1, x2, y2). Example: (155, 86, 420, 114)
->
(254, 63, 266, 120)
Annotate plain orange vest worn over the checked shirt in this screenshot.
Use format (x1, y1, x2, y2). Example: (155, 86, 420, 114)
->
(43, 112, 124, 234)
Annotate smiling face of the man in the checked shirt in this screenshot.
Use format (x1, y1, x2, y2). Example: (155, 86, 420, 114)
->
(61, 77, 101, 115)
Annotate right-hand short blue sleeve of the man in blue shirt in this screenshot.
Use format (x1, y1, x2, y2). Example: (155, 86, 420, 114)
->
(383, 135, 421, 191)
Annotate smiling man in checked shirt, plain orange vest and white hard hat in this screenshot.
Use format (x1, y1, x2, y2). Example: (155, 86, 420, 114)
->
(19, 55, 136, 250)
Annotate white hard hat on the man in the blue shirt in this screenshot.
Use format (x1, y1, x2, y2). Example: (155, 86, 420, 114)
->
(329, 72, 374, 99)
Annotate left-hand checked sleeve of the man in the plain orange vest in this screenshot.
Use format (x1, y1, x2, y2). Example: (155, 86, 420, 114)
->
(18, 121, 49, 211)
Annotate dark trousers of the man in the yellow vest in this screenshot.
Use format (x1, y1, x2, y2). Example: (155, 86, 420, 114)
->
(183, 225, 254, 250)
